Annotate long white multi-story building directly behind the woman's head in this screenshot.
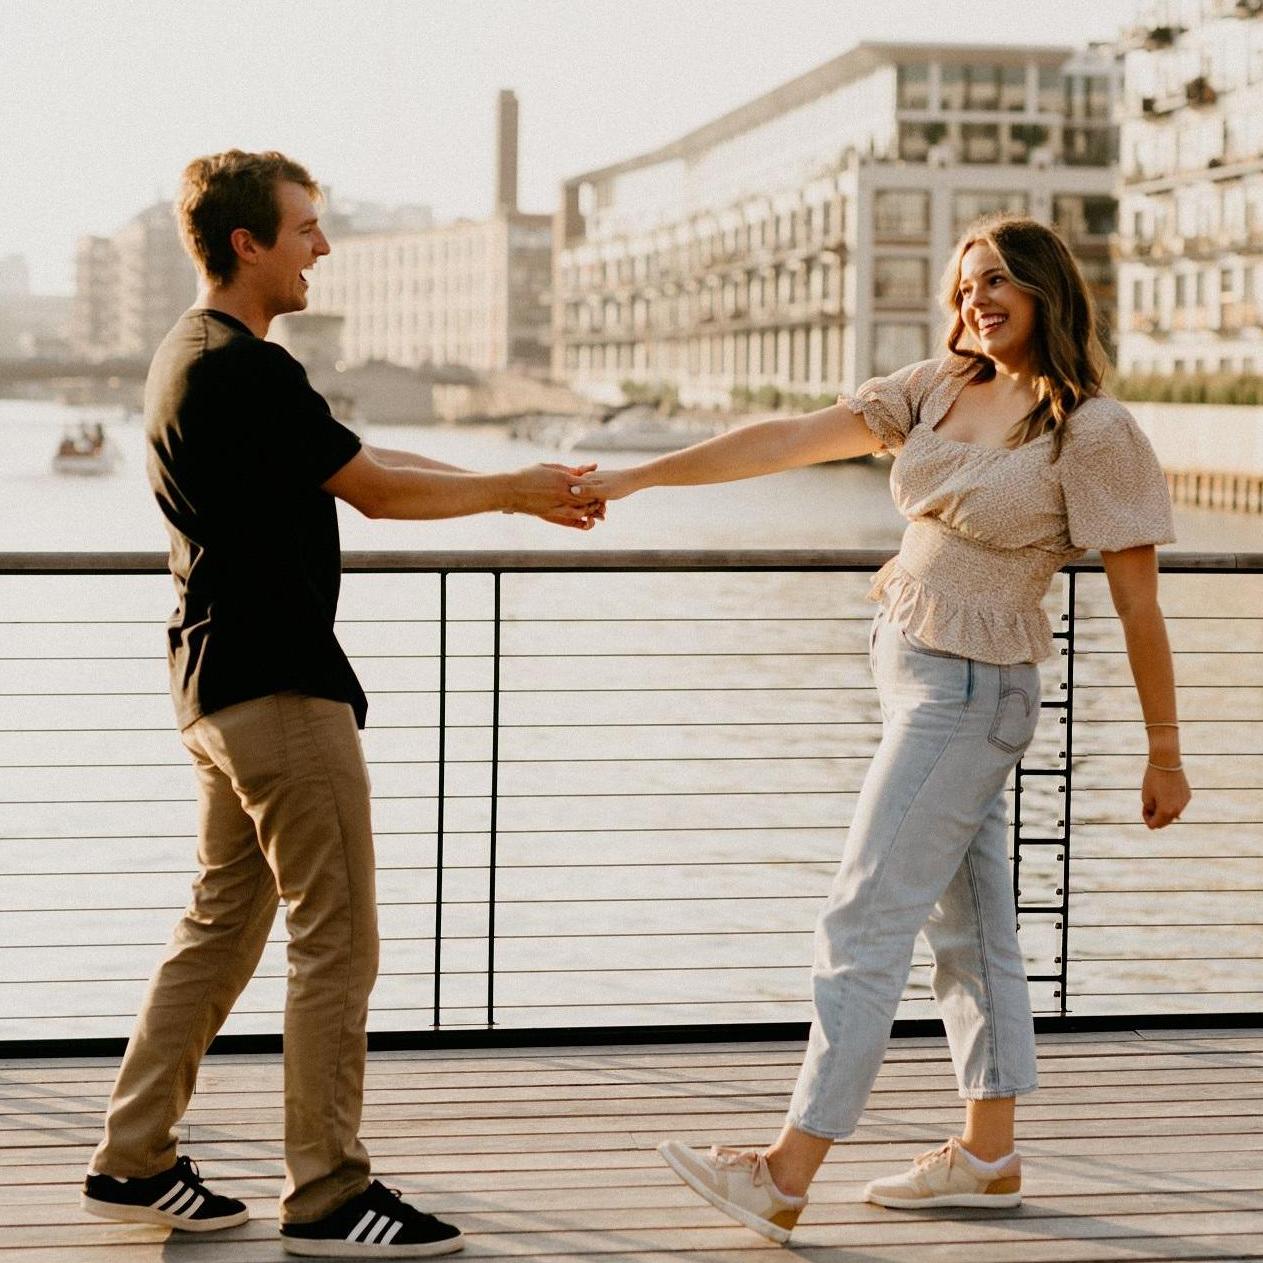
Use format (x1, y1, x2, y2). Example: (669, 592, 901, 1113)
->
(553, 43, 1118, 407)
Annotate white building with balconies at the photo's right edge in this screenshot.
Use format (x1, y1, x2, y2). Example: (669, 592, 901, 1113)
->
(1118, 0, 1263, 374)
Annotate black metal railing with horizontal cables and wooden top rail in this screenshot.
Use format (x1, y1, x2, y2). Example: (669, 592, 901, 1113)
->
(0, 551, 1263, 1051)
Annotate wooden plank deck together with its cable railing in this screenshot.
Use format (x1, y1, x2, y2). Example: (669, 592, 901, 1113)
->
(7, 551, 1263, 1263)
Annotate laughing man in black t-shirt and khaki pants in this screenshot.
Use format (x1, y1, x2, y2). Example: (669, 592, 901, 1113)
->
(83, 150, 600, 1258)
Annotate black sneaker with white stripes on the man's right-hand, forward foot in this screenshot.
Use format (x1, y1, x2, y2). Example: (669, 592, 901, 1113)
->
(280, 1180, 465, 1259)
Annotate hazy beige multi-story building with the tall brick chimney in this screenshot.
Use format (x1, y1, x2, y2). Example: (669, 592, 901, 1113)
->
(308, 92, 552, 370)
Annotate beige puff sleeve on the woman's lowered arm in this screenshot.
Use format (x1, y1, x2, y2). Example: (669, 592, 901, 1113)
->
(1057, 399, 1176, 552)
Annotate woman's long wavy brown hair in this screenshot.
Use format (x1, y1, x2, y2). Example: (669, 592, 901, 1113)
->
(942, 215, 1109, 460)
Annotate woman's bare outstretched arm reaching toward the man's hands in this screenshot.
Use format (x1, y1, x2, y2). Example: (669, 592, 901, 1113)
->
(584, 404, 882, 500)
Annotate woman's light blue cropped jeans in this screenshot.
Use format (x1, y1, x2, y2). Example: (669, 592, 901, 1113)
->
(788, 611, 1039, 1139)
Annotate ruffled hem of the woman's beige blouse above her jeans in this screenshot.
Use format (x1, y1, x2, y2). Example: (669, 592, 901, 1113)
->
(868, 558, 1052, 664)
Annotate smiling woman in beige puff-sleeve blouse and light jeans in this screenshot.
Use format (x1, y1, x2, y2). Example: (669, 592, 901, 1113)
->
(584, 216, 1190, 1242)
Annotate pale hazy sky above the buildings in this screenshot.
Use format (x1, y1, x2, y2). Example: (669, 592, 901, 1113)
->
(0, 0, 1135, 293)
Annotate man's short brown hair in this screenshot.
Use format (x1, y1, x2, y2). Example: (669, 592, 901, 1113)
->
(176, 149, 320, 285)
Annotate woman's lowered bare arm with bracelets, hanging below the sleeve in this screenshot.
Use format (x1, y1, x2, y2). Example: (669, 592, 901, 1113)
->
(1101, 544, 1192, 829)
